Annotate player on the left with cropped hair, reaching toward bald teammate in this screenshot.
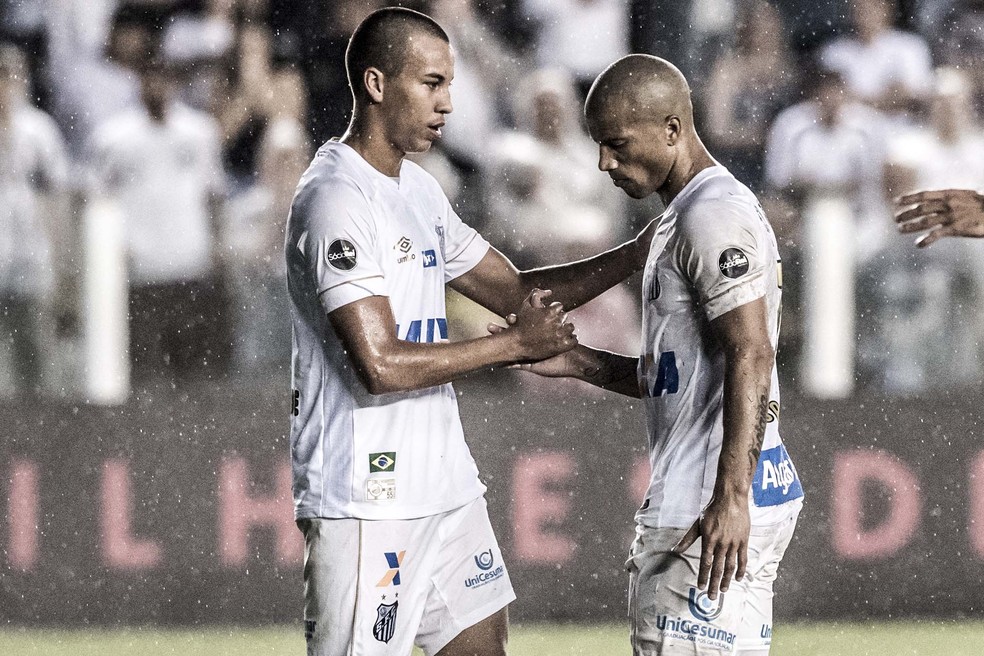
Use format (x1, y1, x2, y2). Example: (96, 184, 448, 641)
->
(285, 8, 652, 656)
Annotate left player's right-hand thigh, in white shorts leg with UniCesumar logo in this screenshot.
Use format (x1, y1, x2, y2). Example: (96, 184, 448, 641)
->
(417, 498, 516, 656)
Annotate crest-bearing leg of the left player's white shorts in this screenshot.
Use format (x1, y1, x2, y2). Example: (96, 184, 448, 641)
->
(298, 516, 440, 656)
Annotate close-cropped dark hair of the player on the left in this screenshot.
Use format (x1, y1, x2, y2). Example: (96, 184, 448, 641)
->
(345, 7, 450, 99)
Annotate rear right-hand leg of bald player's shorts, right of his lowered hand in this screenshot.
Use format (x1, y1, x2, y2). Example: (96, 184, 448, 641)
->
(737, 515, 797, 656)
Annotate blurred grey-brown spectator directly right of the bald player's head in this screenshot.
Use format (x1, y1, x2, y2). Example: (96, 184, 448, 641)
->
(704, 0, 797, 191)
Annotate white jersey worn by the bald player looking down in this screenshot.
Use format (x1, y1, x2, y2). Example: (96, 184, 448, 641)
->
(636, 166, 803, 528)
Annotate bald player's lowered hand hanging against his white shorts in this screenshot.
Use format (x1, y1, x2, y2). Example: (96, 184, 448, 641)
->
(674, 497, 751, 600)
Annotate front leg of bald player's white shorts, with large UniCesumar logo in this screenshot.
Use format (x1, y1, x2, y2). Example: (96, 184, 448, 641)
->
(627, 527, 744, 656)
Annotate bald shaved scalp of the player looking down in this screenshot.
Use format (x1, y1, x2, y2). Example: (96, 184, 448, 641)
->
(584, 55, 694, 128)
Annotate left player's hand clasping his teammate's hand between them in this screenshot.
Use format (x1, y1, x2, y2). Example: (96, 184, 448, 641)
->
(507, 289, 577, 360)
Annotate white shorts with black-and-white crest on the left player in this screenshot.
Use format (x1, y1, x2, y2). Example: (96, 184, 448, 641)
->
(297, 497, 516, 656)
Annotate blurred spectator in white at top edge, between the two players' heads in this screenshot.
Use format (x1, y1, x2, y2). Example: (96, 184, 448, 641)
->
(521, 0, 628, 97)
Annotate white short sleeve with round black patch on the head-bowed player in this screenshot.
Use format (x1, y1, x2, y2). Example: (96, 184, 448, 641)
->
(679, 202, 775, 321)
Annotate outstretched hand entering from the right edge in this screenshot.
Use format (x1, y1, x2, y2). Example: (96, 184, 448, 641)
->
(895, 189, 984, 248)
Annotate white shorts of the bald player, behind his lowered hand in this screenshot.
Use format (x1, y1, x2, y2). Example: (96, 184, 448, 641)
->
(626, 506, 799, 656)
